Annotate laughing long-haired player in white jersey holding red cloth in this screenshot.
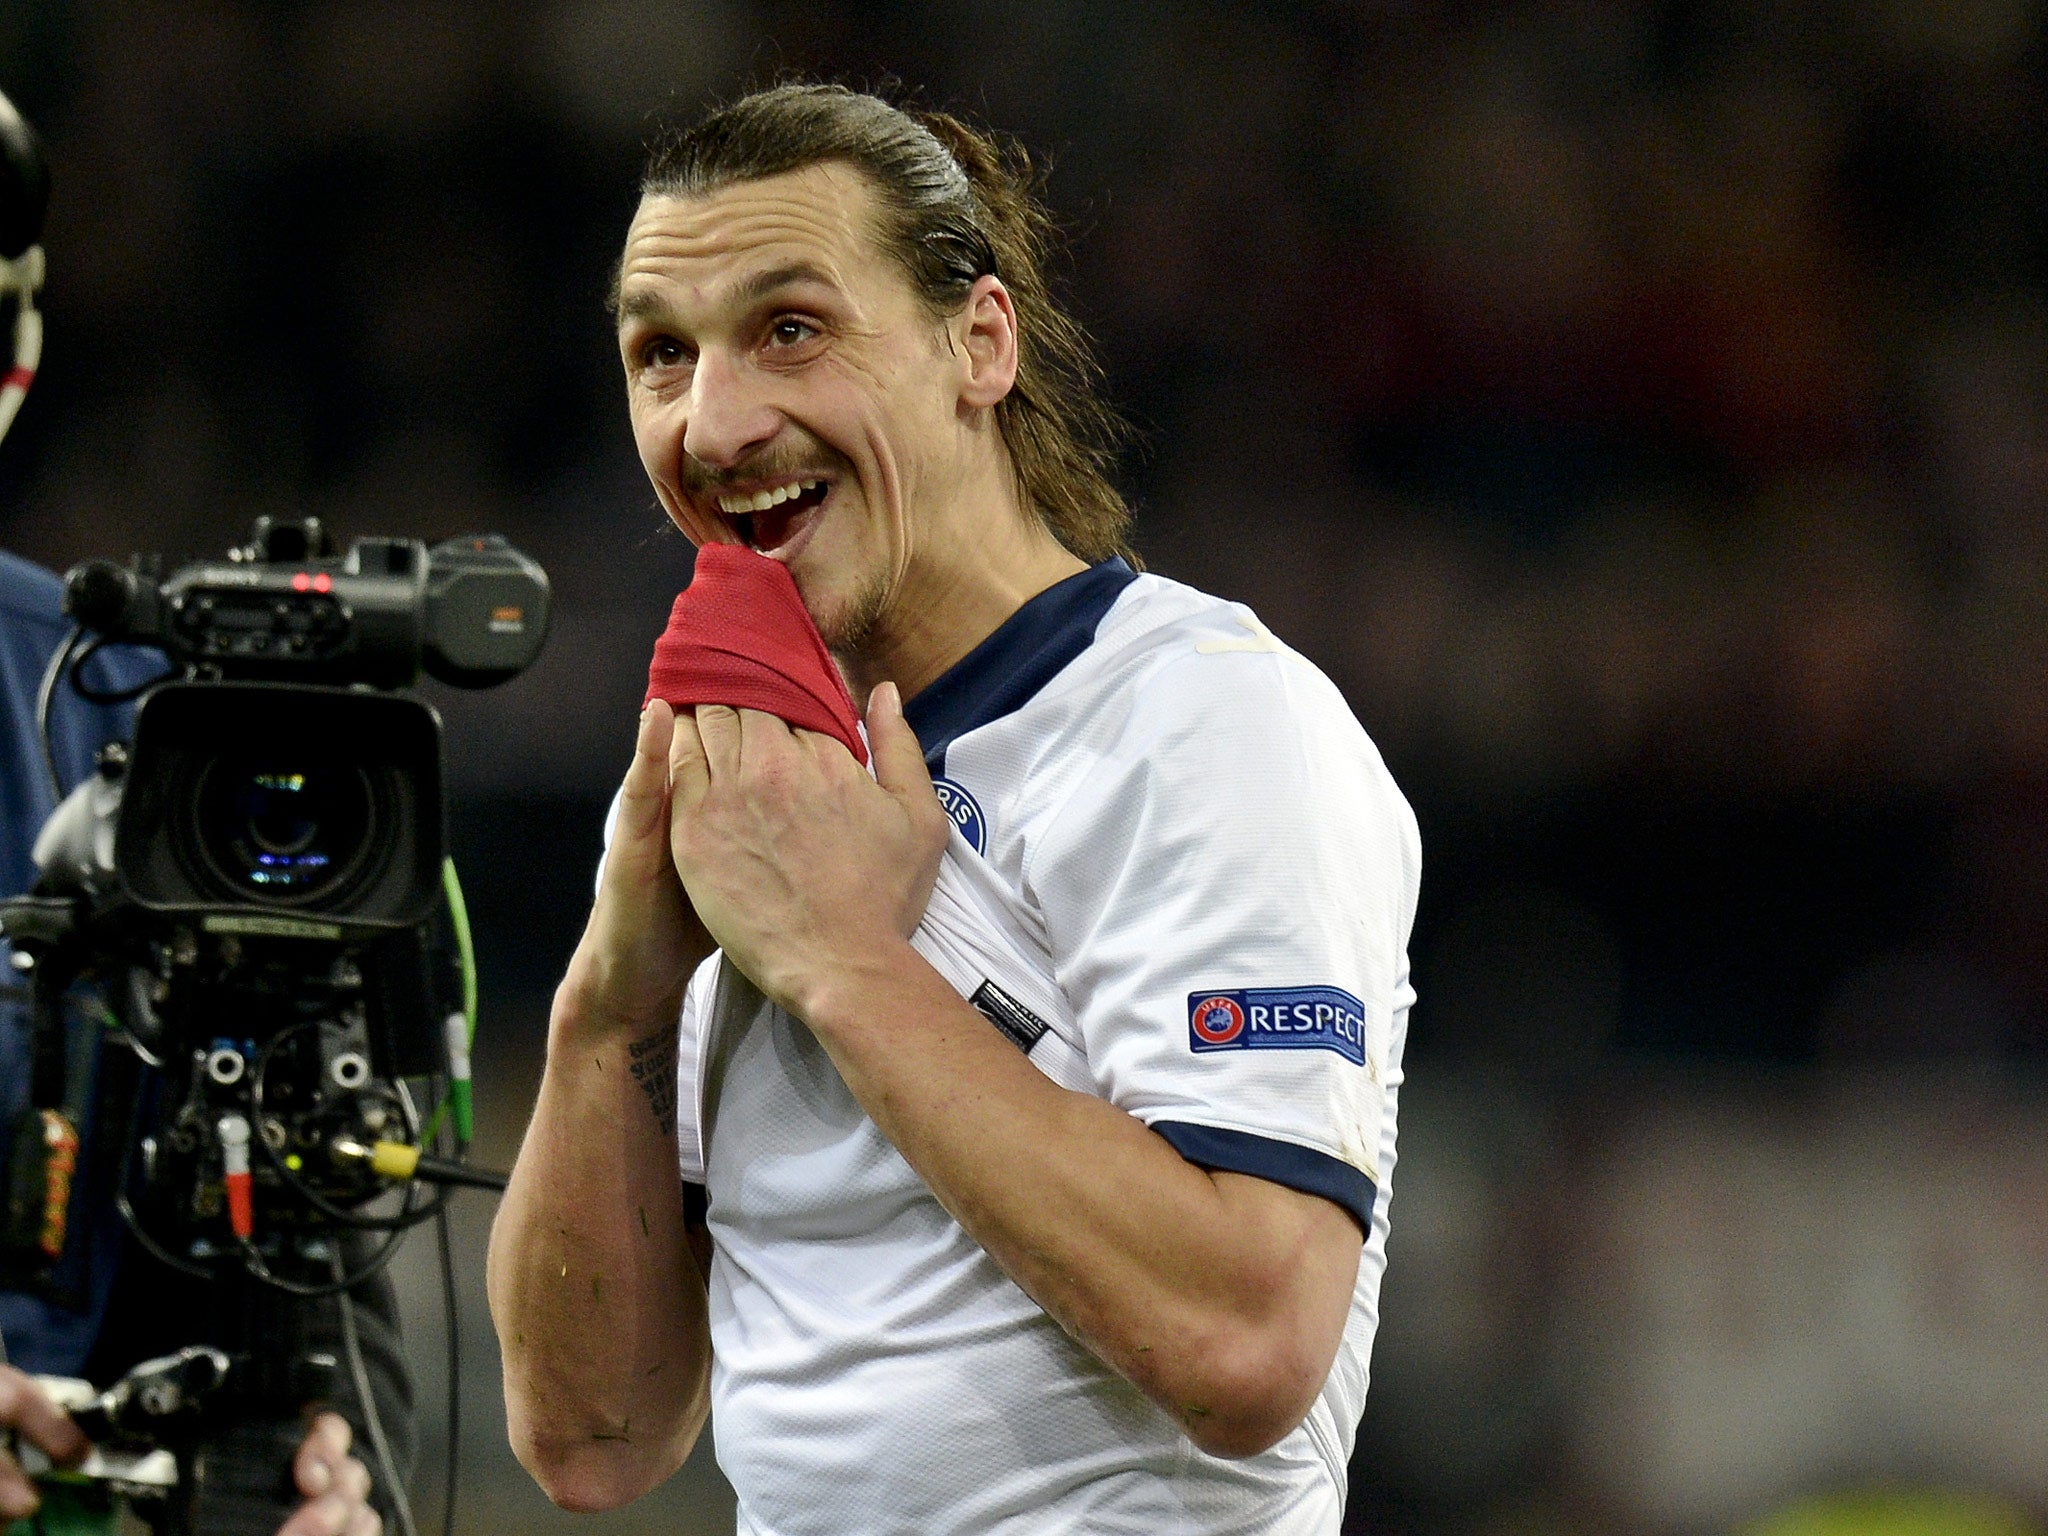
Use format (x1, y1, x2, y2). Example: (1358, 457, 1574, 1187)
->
(489, 86, 1419, 1536)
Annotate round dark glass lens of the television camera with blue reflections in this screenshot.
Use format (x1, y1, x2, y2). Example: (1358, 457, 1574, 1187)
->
(195, 758, 377, 907)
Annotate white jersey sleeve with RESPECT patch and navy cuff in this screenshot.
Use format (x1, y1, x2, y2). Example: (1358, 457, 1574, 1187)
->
(1028, 643, 1421, 1231)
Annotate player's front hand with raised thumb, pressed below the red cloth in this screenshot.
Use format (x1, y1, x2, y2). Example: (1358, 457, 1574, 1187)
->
(670, 682, 946, 1018)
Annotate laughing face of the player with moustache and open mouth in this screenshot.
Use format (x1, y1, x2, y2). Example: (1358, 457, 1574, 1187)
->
(618, 164, 1008, 651)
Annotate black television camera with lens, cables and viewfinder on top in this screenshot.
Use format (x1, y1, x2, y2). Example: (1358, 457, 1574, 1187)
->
(0, 520, 549, 1294)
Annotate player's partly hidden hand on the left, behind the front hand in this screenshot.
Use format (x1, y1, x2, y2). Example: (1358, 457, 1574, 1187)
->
(561, 698, 711, 1036)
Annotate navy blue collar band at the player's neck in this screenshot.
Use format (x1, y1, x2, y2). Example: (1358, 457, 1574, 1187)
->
(903, 555, 1137, 778)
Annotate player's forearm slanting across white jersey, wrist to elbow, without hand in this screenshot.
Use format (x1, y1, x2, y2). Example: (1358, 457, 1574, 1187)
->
(803, 944, 1360, 1454)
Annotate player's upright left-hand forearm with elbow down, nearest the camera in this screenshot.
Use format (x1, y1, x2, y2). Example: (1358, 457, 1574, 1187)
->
(487, 983, 711, 1507)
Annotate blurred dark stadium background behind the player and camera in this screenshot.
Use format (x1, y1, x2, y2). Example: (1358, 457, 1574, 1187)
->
(0, 0, 2048, 1536)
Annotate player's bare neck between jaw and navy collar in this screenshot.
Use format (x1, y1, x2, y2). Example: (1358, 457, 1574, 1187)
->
(836, 475, 1087, 713)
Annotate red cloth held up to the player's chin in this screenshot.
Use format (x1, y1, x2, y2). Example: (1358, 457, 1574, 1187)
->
(641, 545, 868, 766)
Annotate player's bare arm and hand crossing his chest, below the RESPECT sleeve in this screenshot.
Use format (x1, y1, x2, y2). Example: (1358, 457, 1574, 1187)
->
(672, 686, 1362, 1454)
